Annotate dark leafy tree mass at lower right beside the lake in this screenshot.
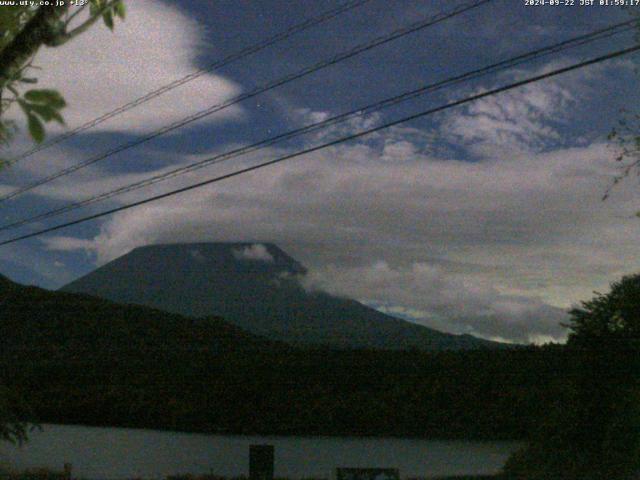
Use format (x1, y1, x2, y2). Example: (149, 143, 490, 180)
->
(506, 275, 640, 480)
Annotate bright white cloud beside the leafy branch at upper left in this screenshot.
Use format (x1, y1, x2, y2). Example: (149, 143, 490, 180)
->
(5, 0, 241, 140)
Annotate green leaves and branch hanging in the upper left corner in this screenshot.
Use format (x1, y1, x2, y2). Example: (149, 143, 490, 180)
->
(0, 0, 125, 146)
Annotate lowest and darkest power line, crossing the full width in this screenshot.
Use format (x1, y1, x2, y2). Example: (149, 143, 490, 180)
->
(0, 45, 640, 246)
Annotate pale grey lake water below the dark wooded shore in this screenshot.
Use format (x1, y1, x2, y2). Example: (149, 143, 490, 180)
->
(0, 425, 519, 479)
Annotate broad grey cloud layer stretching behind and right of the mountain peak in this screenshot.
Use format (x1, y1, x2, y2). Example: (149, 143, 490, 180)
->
(37, 122, 640, 341)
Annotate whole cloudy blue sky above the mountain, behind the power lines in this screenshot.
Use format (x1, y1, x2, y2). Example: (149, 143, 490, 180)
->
(0, 0, 640, 343)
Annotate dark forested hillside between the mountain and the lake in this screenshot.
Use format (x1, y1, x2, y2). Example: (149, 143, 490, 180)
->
(0, 276, 576, 439)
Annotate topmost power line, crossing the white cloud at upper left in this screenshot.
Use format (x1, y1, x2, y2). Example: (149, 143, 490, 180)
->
(5, 0, 371, 167)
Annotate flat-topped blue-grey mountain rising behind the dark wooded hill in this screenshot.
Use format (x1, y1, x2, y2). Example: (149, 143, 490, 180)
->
(62, 243, 498, 350)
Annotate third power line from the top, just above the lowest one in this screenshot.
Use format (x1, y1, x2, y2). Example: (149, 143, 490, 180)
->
(0, 15, 639, 231)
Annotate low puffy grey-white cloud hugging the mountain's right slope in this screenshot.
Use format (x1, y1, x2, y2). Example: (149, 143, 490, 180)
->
(305, 261, 565, 342)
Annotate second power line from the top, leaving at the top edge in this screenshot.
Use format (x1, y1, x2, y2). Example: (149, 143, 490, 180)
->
(0, 0, 493, 202)
